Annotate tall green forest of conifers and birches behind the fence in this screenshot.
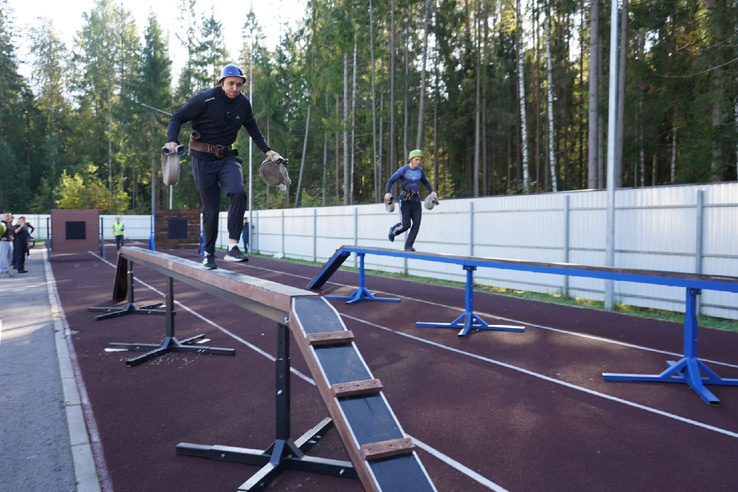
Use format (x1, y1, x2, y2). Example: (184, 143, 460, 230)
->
(0, 0, 738, 214)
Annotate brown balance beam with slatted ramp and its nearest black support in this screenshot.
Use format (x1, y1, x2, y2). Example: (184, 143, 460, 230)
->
(110, 247, 436, 492)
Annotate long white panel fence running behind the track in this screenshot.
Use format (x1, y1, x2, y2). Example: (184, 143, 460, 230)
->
(16, 183, 738, 319)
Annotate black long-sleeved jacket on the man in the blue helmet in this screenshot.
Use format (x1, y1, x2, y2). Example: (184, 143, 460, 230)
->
(167, 86, 272, 160)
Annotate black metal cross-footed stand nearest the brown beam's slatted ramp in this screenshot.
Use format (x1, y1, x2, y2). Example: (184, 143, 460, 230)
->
(177, 323, 359, 492)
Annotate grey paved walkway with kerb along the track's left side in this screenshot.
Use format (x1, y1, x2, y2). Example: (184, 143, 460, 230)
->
(0, 245, 100, 492)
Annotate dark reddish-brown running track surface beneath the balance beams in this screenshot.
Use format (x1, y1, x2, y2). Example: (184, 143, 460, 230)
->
(51, 247, 738, 492)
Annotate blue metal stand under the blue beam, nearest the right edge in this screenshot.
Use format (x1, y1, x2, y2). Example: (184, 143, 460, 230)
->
(602, 288, 738, 407)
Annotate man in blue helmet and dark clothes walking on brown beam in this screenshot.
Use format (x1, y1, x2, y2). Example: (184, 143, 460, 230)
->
(165, 65, 281, 269)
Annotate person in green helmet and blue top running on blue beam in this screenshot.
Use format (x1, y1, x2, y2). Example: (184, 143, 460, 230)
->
(384, 149, 438, 251)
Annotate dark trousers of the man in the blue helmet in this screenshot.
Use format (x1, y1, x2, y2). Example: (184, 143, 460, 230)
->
(191, 155, 246, 255)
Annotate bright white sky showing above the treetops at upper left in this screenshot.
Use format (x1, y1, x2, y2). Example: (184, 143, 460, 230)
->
(7, 0, 307, 78)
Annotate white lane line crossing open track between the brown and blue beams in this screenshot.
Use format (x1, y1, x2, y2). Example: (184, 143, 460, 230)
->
(341, 314, 738, 438)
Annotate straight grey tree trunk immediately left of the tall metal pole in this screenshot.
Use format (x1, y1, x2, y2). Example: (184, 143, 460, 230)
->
(587, 0, 600, 189)
